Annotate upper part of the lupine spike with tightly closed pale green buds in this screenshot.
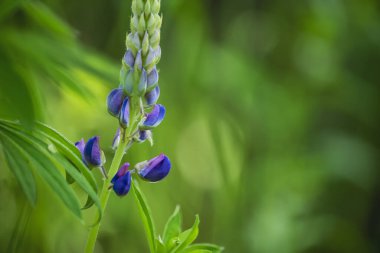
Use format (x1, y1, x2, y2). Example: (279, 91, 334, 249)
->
(120, 0, 162, 102)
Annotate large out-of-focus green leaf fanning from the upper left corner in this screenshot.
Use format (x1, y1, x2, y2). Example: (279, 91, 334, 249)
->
(0, 1, 113, 127)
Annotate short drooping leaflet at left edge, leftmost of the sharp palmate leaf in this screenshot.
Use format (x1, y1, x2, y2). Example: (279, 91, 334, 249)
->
(3, 138, 37, 207)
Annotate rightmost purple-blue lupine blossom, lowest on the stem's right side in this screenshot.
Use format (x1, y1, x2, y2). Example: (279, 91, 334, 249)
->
(138, 154, 171, 182)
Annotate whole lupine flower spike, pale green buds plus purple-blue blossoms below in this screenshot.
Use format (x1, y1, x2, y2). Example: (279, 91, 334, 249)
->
(76, 0, 171, 196)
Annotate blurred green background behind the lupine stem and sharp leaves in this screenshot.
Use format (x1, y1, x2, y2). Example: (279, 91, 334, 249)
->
(0, 0, 380, 253)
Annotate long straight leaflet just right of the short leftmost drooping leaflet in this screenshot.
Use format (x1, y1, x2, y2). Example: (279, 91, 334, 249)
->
(0, 124, 82, 218)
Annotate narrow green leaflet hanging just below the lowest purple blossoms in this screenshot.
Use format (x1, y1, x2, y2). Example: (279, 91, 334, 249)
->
(131, 180, 156, 253)
